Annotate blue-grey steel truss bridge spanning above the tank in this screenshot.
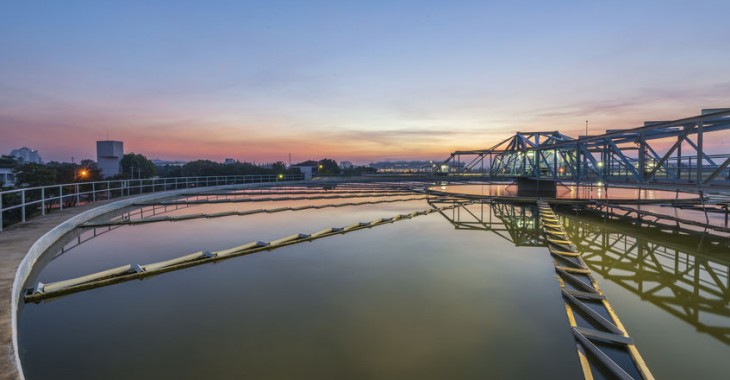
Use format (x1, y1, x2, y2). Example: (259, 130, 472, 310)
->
(437, 109, 730, 186)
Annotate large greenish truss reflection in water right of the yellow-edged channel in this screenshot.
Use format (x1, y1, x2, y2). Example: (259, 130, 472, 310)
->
(563, 216, 730, 344)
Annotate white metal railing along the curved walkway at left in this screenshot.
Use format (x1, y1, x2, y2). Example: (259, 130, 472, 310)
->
(0, 174, 304, 231)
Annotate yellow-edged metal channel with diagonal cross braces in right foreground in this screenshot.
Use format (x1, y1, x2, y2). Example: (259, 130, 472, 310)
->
(538, 200, 654, 379)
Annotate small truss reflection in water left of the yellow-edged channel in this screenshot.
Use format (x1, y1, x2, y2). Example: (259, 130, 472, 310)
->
(429, 199, 545, 247)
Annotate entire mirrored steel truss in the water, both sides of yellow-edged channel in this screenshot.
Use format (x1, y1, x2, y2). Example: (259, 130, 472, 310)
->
(442, 203, 730, 344)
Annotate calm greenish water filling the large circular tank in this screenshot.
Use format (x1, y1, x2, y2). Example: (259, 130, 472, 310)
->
(20, 183, 730, 380)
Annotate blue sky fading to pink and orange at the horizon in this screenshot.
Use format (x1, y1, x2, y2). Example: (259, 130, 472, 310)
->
(0, 0, 730, 163)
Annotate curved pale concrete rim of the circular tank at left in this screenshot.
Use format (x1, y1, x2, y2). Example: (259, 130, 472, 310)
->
(10, 181, 309, 380)
